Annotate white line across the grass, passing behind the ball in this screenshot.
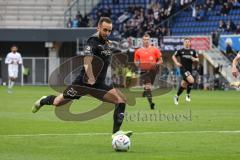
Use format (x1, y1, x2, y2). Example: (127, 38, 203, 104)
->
(0, 130, 240, 137)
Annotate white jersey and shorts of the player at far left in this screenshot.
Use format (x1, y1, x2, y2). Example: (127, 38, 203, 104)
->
(5, 52, 22, 78)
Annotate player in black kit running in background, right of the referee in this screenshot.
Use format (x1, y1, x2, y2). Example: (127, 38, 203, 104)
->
(172, 38, 199, 105)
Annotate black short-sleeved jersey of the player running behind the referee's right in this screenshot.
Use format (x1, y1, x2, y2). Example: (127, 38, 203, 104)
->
(174, 48, 198, 71)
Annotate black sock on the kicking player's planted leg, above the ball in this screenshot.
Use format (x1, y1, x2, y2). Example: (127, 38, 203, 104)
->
(113, 103, 126, 133)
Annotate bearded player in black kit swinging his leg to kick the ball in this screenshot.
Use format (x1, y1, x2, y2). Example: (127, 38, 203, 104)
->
(32, 17, 132, 137)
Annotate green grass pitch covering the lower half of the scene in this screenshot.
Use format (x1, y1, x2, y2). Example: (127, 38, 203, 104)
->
(0, 87, 240, 160)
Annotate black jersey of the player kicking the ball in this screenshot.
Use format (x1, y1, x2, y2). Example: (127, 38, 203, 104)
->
(75, 33, 112, 83)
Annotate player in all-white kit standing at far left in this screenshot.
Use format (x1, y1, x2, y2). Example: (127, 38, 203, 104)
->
(5, 45, 22, 93)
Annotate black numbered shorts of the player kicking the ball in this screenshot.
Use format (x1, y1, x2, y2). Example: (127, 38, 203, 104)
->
(63, 82, 113, 100)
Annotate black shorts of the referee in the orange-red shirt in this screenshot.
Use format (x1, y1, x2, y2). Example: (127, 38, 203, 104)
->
(140, 69, 158, 84)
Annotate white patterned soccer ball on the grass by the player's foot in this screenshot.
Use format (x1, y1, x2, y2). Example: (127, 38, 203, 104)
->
(112, 134, 131, 152)
